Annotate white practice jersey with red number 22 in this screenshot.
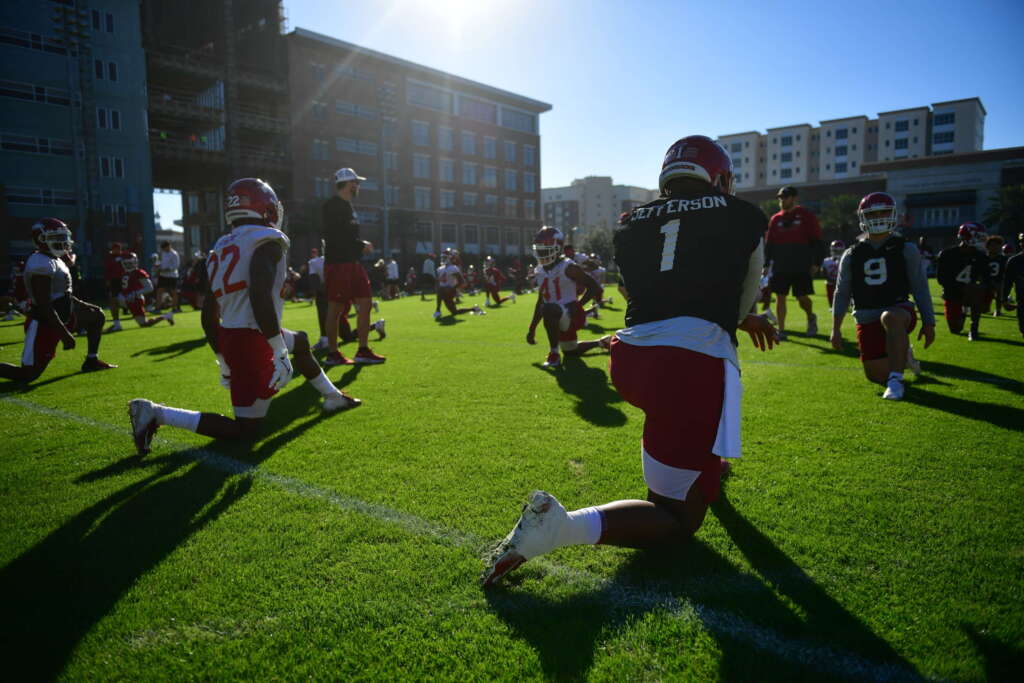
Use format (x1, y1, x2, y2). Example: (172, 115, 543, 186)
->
(206, 225, 289, 330)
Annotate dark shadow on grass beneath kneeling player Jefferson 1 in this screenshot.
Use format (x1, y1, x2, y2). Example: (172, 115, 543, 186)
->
(484, 497, 918, 681)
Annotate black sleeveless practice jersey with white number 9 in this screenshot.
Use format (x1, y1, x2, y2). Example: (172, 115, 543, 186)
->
(848, 236, 910, 309)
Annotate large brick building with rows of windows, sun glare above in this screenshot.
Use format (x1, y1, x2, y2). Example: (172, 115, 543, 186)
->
(286, 29, 551, 266)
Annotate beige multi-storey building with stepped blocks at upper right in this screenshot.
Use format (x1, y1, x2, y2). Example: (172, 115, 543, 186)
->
(718, 97, 986, 191)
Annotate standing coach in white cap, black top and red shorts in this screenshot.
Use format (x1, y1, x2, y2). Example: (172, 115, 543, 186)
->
(322, 168, 385, 366)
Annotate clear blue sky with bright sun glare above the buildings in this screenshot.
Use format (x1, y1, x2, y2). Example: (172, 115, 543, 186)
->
(155, 0, 1024, 223)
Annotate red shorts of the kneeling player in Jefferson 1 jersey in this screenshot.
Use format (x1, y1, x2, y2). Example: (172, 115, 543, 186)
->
(608, 337, 727, 504)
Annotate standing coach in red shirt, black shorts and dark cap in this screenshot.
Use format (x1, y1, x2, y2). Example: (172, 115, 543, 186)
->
(765, 185, 825, 339)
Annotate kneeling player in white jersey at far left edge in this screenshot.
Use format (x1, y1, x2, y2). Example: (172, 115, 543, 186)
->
(0, 218, 117, 382)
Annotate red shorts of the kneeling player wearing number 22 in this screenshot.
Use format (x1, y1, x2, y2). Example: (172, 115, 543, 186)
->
(217, 328, 278, 418)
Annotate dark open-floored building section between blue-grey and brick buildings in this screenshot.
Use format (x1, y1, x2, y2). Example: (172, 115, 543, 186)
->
(142, 0, 292, 259)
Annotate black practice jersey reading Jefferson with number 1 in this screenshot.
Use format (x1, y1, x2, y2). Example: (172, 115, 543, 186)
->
(614, 190, 768, 337)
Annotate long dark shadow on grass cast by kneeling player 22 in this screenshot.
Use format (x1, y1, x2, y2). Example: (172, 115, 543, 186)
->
(0, 384, 338, 680)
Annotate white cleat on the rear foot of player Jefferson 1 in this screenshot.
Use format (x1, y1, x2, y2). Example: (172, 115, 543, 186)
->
(480, 490, 568, 586)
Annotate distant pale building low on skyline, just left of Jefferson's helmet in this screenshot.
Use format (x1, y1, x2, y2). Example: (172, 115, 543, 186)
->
(541, 175, 657, 239)
